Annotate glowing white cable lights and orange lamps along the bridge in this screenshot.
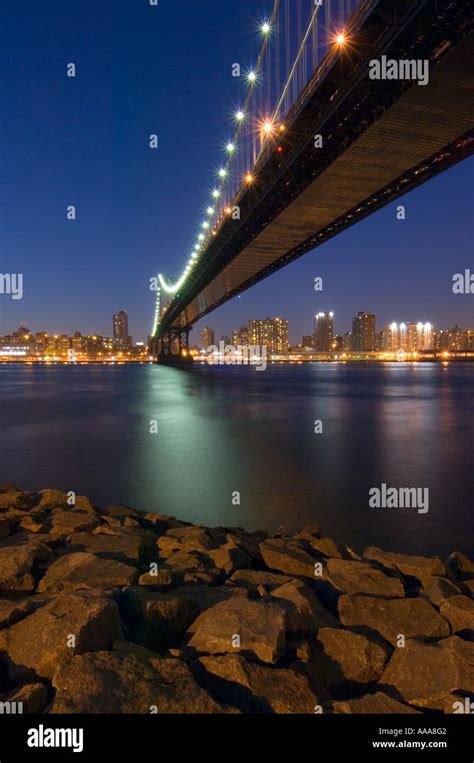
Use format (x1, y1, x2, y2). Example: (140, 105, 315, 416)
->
(153, 12, 346, 320)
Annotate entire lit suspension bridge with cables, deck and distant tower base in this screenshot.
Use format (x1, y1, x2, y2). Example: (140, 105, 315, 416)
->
(151, 0, 474, 362)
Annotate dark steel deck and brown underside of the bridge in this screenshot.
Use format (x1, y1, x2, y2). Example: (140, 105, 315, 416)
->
(160, 3, 474, 333)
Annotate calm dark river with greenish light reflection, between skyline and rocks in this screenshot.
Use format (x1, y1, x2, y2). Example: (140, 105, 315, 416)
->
(0, 363, 474, 554)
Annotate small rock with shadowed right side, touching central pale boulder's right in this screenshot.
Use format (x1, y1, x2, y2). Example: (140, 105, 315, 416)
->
(271, 580, 338, 637)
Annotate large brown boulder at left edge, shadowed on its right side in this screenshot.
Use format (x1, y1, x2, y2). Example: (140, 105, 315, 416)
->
(0, 593, 123, 678)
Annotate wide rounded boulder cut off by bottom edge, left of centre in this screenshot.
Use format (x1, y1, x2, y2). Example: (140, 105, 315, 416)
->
(50, 651, 233, 714)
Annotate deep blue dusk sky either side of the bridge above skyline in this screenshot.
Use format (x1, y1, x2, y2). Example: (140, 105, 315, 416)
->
(0, 0, 474, 341)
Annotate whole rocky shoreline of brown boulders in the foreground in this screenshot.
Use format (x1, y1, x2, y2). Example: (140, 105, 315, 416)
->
(0, 483, 474, 714)
